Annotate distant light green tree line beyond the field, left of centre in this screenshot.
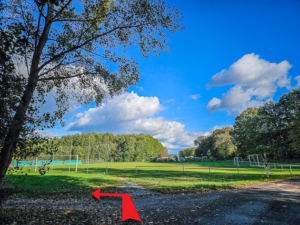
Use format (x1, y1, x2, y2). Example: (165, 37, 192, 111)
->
(20, 133, 168, 162)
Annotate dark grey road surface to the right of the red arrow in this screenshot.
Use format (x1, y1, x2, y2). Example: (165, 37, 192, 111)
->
(135, 178, 300, 225)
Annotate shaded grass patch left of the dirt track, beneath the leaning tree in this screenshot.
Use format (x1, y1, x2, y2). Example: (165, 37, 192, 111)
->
(3, 174, 122, 199)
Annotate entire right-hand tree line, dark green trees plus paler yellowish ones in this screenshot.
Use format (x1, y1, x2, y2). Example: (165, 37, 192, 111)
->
(195, 89, 300, 160)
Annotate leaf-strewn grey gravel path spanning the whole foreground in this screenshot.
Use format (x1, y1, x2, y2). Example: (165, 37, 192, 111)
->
(2, 178, 300, 225)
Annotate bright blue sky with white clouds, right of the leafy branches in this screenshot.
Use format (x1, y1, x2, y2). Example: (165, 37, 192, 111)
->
(40, 0, 300, 153)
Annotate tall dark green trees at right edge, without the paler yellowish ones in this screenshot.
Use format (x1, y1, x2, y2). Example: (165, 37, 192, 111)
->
(232, 89, 300, 159)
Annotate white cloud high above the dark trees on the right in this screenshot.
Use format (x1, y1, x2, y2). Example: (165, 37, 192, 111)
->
(207, 53, 291, 114)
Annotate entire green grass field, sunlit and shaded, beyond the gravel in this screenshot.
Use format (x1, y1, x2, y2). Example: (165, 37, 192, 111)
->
(4, 162, 300, 198)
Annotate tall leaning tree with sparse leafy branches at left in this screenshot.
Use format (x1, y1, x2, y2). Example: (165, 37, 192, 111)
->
(0, 0, 182, 185)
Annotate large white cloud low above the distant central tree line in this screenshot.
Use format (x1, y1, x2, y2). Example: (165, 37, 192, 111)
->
(68, 92, 200, 150)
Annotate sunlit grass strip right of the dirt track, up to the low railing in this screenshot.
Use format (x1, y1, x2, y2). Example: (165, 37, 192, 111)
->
(75, 168, 300, 193)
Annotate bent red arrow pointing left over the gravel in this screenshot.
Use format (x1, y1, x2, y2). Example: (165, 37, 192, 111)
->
(92, 188, 142, 222)
